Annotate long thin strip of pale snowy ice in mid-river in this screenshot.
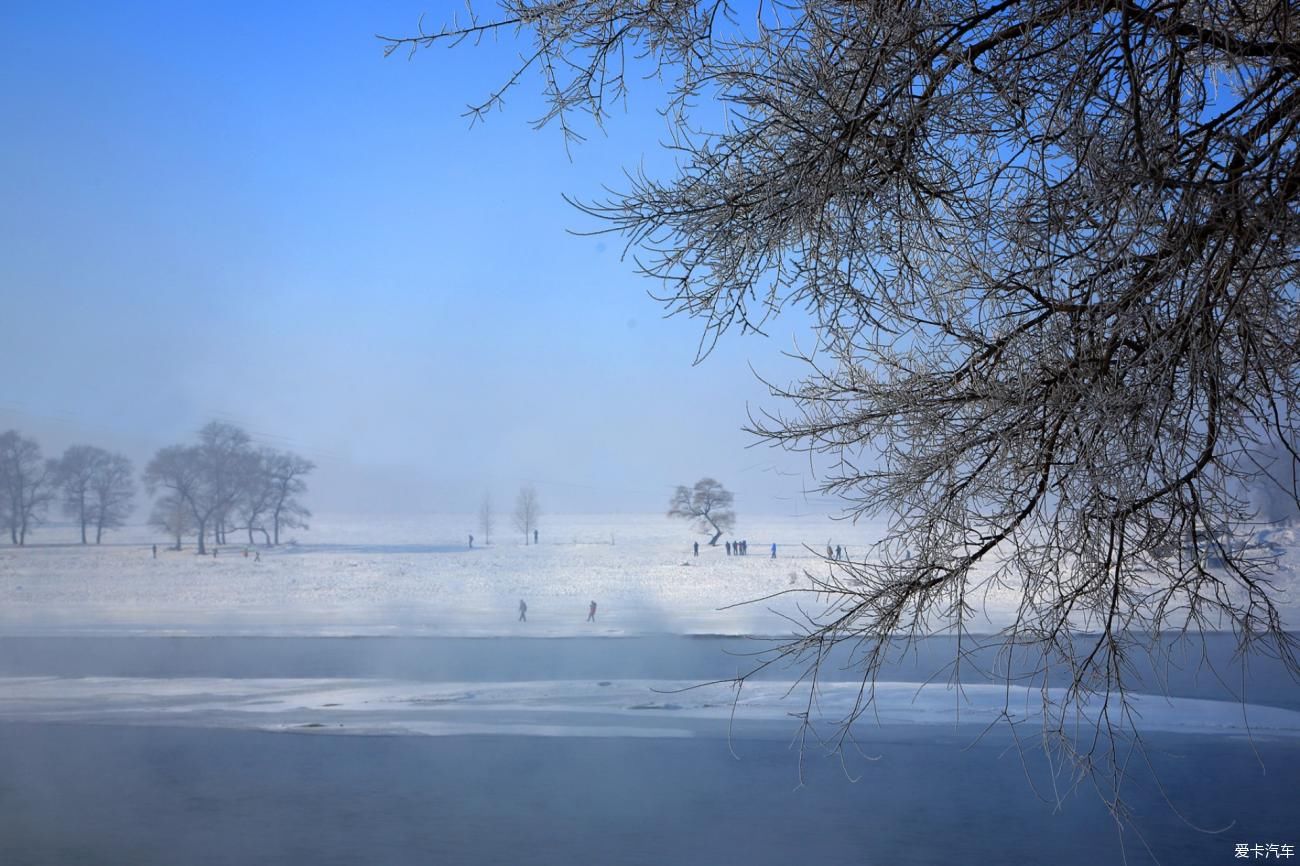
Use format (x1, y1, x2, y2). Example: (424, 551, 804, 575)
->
(0, 677, 1300, 739)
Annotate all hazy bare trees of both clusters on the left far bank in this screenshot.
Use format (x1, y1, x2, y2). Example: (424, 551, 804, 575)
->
(0, 421, 316, 553)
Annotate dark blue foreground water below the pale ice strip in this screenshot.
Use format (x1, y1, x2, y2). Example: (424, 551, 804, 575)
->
(0, 724, 1300, 866)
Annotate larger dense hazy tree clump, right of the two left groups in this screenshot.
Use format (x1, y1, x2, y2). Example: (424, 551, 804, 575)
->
(144, 421, 316, 554)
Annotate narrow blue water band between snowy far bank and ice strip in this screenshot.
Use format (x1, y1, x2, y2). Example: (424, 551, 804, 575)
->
(0, 635, 1300, 710)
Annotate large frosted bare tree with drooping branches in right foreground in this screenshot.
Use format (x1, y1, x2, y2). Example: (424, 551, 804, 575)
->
(389, 0, 1300, 811)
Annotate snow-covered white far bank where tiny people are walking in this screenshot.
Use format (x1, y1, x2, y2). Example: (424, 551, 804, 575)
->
(0, 515, 1300, 637)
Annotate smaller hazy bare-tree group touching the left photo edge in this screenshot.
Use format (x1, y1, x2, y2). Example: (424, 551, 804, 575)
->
(0, 430, 135, 545)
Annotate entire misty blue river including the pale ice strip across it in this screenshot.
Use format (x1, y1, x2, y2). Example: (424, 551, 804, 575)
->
(0, 636, 1300, 866)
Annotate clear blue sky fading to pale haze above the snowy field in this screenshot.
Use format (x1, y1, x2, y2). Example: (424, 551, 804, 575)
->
(0, 0, 826, 514)
